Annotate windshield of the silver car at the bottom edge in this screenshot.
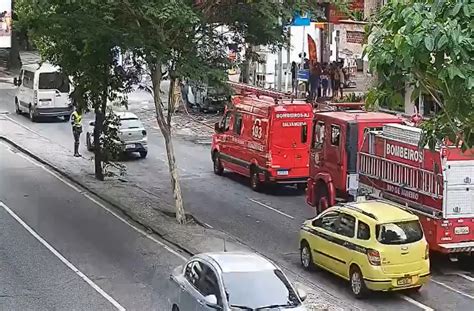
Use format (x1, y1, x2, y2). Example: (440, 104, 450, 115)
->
(223, 270, 300, 309)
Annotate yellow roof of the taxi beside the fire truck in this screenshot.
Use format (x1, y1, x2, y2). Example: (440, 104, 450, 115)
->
(340, 200, 418, 223)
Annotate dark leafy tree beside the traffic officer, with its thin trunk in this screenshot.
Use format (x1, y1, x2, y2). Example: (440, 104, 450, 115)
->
(17, 0, 133, 180)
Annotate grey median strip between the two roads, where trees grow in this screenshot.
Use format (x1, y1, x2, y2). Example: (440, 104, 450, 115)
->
(0, 114, 346, 310)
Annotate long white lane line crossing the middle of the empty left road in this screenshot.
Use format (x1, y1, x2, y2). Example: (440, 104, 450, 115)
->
(0, 202, 126, 311)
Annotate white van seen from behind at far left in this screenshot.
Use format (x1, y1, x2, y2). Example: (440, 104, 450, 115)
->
(14, 63, 73, 122)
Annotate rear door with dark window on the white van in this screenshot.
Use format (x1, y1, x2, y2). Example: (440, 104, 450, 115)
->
(38, 72, 70, 108)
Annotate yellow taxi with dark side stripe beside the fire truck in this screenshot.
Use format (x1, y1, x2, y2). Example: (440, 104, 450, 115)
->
(300, 200, 430, 298)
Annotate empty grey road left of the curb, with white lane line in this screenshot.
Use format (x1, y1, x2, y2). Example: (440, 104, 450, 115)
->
(0, 143, 188, 310)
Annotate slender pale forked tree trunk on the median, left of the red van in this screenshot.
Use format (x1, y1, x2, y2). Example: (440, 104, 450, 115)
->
(150, 62, 186, 224)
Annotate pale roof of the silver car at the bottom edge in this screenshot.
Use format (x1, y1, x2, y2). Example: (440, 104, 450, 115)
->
(196, 252, 278, 273)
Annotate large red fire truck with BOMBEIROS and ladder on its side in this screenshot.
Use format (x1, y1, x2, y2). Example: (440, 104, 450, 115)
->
(307, 111, 474, 258)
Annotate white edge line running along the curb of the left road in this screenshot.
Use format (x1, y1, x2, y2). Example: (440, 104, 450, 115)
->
(0, 144, 188, 261)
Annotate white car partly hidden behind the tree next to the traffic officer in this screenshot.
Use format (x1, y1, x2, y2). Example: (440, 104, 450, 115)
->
(86, 112, 148, 158)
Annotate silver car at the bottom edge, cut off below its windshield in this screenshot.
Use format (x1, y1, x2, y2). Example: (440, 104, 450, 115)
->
(170, 253, 306, 311)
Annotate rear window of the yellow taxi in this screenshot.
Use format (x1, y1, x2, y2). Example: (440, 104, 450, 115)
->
(376, 220, 423, 245)
